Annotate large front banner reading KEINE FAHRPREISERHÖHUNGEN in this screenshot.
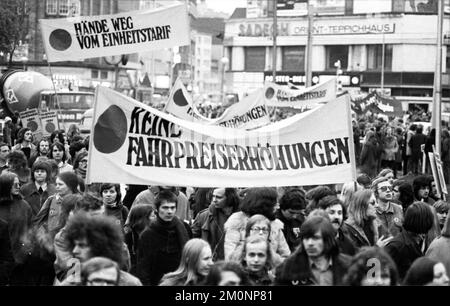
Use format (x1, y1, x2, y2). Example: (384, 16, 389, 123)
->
(87, 86, 355, 187)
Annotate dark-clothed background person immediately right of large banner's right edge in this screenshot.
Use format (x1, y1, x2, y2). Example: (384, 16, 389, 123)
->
(359, 131, 381, 178)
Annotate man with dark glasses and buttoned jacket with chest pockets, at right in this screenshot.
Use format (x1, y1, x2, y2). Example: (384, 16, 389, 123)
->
(372, 177, 403, 237)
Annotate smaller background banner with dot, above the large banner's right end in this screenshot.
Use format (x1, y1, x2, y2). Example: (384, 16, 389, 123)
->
(264, 78, 336, 109)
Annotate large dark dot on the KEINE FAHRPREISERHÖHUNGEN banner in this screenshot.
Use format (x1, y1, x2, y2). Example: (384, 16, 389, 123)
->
(94, 105, 127, 154)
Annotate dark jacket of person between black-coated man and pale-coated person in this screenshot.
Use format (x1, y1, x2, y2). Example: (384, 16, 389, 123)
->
(192, 205, 229, 260)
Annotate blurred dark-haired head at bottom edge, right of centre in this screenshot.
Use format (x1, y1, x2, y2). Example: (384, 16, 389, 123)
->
(343, 246, 398, 286)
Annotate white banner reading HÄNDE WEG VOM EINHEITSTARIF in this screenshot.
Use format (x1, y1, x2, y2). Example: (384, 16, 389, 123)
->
(39, 3, 190, 62)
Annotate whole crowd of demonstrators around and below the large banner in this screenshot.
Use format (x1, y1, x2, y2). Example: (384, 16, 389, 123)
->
(0, 121, 450, 286)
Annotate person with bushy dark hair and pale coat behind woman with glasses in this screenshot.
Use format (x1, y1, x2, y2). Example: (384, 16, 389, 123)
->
(224, 187, 291, 265)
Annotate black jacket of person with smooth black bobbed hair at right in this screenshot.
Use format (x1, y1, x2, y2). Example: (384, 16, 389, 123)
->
(384, 230, 424, 279)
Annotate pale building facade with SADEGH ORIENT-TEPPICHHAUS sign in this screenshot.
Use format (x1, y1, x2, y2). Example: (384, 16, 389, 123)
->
(224, 0, 450, 112)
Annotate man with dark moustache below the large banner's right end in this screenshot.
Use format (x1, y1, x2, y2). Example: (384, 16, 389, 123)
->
(319, 196, 356, 256)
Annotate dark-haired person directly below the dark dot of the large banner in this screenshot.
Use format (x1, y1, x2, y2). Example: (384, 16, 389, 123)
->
(101, 183, 129, 228)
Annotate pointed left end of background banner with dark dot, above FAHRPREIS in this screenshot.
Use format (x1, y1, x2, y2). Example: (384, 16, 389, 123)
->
(164, 77, 212, 124)
